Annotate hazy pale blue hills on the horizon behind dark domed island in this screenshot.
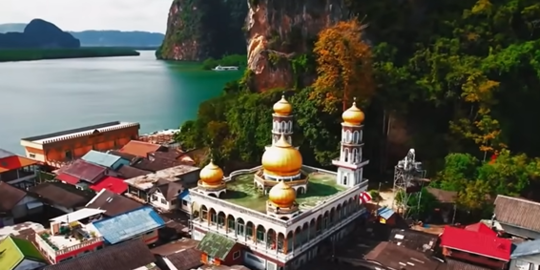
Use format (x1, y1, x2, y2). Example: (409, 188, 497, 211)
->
(0, 23, 165, 48)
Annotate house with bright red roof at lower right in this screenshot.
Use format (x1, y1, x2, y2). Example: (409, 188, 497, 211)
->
(440, 223, 512, 270)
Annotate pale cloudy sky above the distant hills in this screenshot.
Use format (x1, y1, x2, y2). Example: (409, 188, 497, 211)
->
(0, 0, 172, 33)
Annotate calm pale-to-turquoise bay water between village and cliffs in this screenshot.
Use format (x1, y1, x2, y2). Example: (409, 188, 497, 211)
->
(0, 51, 242, 153)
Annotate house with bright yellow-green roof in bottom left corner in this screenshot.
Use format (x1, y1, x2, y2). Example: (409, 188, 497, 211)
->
(0, 236, 47, 270)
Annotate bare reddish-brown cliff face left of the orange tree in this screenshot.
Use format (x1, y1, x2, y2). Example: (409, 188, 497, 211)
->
(245, 0, 349, 91)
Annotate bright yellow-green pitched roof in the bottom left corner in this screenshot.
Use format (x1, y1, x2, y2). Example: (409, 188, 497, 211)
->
(0, 236, 45, 270)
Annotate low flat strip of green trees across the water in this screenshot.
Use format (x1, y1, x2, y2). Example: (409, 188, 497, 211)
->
(0, 47, 140, 62)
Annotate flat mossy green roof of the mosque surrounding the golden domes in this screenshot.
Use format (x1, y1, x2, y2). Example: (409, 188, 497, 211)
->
(223, 172, 346, 213)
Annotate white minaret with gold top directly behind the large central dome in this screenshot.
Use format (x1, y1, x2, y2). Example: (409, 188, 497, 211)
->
(272, 95, 293, 145)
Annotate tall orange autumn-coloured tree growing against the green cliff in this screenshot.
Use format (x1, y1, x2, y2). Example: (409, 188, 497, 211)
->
(313, 20, 375, 112)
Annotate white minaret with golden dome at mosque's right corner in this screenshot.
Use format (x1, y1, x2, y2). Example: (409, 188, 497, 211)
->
(332, 98, 369, 187)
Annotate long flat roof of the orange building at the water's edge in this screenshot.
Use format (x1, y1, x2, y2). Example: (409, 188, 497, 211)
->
(21, 121, 139, 144)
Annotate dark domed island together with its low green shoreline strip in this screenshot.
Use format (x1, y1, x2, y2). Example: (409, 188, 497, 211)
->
(0, 19, 139, 62)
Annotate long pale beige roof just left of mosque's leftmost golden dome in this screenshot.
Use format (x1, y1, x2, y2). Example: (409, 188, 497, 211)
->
(125, 165, 200, 190)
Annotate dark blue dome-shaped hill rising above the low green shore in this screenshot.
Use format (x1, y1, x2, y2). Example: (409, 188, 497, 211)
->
(0, 19, 81, 49)
